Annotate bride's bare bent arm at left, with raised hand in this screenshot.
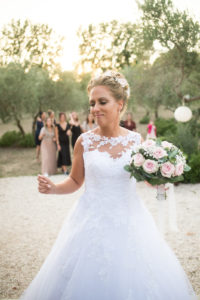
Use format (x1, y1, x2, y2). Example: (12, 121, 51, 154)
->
(38, 137, 84, 194)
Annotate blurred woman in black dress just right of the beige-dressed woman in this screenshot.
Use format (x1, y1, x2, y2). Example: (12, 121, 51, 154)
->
(56, 112, 71, 175)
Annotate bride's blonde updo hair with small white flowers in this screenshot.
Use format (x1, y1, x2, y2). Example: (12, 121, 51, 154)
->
(87, 71, 130, 112)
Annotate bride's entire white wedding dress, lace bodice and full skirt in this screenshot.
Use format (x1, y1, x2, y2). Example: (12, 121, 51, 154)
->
(20, 131, 196, 300)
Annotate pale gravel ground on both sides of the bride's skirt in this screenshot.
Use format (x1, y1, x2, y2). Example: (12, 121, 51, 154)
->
(0, 175, 200, 299)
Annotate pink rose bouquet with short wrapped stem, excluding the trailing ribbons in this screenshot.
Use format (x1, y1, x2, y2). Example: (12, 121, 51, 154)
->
(125, 139, 191, 200)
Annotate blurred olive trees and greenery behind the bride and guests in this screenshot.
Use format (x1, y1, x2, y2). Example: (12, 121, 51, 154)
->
(0, 0, 200, 183)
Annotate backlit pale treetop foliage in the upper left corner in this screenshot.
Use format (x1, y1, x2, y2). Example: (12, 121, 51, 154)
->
(0, 20, 63, 74)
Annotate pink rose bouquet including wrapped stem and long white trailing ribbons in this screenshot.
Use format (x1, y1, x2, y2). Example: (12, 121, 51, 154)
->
(124, 139, 191, 231)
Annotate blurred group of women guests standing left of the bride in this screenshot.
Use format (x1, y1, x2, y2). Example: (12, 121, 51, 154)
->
(35, 110, 96, 176)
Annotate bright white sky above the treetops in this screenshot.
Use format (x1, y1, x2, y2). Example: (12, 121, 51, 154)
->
(0, 0, 200, 70)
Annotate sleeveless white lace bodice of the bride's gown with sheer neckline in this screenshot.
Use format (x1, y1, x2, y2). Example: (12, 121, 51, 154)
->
(82, 131, 141, 206)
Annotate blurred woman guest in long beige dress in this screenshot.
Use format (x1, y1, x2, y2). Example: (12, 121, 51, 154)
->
(39, 117, 57, 176)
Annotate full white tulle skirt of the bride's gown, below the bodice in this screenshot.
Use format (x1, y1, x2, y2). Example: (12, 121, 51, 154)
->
(20, 194, 197, 300)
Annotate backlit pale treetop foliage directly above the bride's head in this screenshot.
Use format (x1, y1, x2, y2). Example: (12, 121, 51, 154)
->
(78, 20, 151, 71)
